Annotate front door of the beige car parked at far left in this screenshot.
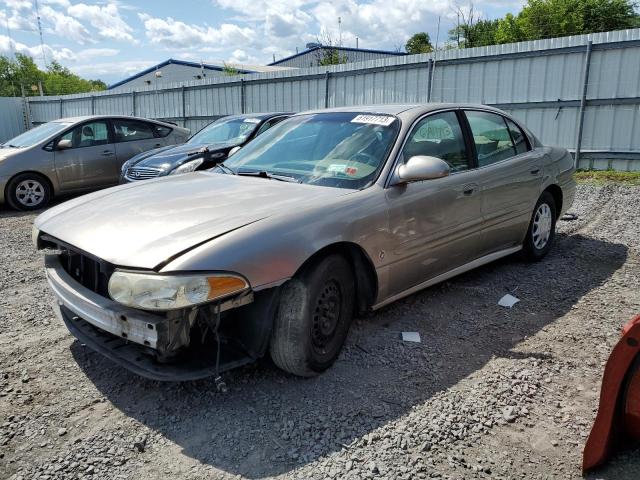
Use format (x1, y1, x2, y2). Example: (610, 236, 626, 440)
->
(54, 120, 118, 190)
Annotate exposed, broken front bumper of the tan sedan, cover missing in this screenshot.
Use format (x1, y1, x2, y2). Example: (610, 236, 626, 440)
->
(45, 255, 254, 381)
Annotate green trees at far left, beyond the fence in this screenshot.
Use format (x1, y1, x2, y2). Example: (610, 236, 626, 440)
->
(0, 54, 107, 97)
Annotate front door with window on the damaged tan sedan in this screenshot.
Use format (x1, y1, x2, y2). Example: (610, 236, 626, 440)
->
(387, 111, 483, 295)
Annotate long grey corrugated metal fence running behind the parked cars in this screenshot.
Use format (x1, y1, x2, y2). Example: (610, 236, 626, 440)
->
(3, 29, 640, 170)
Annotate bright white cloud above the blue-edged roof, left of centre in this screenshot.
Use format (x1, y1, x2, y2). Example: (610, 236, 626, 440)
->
(138, 13, 256, 48)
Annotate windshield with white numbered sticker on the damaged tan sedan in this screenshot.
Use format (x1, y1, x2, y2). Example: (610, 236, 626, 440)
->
(224, 112, 400, 189)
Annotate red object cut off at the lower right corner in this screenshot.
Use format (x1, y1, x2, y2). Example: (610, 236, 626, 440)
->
(582, 315, 640, 473)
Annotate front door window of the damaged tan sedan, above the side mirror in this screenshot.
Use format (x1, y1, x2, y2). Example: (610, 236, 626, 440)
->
(402, 112, 470, 172)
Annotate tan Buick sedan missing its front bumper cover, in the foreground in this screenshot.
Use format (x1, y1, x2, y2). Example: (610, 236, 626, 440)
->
(33, 104, 575, 380)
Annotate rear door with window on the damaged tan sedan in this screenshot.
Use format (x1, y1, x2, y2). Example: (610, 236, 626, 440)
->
(465, 110, 542, 254)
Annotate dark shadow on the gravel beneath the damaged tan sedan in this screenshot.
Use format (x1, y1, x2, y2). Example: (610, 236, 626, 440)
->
(71, 235, 627, 478)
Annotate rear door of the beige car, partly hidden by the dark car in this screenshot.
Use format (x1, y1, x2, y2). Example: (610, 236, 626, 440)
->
(112, 118, 168, 167)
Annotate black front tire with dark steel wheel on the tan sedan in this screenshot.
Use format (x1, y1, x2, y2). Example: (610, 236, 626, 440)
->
(270, 255, 355, 377)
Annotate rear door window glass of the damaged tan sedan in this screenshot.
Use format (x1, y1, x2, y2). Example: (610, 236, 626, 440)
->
(465, 111, 516, 167)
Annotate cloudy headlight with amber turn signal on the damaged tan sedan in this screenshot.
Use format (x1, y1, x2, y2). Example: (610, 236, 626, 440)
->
(109, 270, 249, 310)
